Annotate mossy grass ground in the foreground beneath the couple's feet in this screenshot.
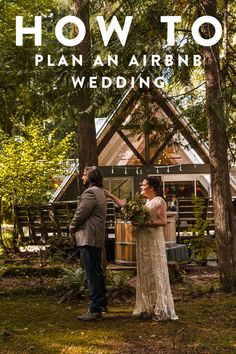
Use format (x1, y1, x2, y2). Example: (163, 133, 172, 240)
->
(0, 273, 236, 354)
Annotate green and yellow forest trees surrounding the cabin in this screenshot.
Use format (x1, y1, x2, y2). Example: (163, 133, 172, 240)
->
(0, 0, 236, 290)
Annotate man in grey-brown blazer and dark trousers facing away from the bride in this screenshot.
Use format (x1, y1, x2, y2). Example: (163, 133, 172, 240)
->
(69, 166, 107, 321)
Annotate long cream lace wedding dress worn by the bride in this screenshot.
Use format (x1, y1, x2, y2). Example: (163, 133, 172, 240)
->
(133, 197, 178, 321)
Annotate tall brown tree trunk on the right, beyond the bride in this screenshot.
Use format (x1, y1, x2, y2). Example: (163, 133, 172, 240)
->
(201, 0, 236, 291)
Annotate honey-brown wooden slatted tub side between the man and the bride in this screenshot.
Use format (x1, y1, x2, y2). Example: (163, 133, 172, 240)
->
(115, 219, 136, 266)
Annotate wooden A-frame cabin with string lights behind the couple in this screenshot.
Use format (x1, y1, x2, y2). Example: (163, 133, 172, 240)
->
(51, 81, 236, 202)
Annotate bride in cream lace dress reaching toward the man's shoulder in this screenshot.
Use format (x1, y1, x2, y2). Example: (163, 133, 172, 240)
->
(105, 176, 178, 321)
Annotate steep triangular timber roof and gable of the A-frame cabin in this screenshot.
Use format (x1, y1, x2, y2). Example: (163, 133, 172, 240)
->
(52, 84, 236, 201)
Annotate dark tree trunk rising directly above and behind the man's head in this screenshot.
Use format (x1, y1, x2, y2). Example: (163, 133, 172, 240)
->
(74, 0, 98, 183)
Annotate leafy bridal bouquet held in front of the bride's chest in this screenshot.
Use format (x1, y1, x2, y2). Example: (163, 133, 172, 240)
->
(121, 199, 148, 224)
